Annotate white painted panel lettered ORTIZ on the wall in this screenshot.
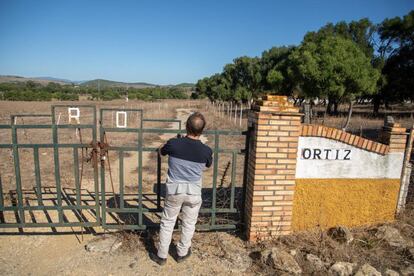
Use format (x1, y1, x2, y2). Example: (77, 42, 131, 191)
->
(296, 137, 403, 179)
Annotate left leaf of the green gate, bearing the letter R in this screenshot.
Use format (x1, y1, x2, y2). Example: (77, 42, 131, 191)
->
(0, 105, 101, 228)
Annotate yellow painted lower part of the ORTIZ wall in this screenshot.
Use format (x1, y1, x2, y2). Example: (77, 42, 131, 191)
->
(292, 179, 400, 231)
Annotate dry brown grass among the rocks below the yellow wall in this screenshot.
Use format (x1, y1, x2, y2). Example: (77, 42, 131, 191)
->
(246, 206, 414, 274)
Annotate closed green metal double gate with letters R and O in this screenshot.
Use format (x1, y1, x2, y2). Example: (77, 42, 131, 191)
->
(0, 105, 248, 233)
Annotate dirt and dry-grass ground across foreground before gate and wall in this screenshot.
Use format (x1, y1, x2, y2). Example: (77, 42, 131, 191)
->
(0, 209, 414, 276)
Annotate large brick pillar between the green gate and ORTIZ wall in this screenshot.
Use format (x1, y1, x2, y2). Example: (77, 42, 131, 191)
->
(245, 96, 301, 240)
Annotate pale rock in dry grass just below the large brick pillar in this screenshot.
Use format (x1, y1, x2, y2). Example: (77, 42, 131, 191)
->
(261, 247, 302, 275)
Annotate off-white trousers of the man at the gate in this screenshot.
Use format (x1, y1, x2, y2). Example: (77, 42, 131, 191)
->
(157, 194, 202, 259)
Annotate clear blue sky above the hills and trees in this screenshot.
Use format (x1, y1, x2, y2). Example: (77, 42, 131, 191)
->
(0, 0, 414, 84)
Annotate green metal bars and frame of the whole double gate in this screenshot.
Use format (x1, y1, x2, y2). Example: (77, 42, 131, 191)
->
(0, 105, 248, 230)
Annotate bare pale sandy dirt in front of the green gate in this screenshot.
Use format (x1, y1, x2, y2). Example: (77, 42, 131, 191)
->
(0, 233, 253, 275)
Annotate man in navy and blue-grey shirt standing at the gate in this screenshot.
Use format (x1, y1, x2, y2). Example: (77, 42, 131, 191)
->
(150, 112, 213, 265)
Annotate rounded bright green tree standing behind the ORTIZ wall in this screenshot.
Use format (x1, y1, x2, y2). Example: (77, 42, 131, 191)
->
(289, 35, 379, 128)
